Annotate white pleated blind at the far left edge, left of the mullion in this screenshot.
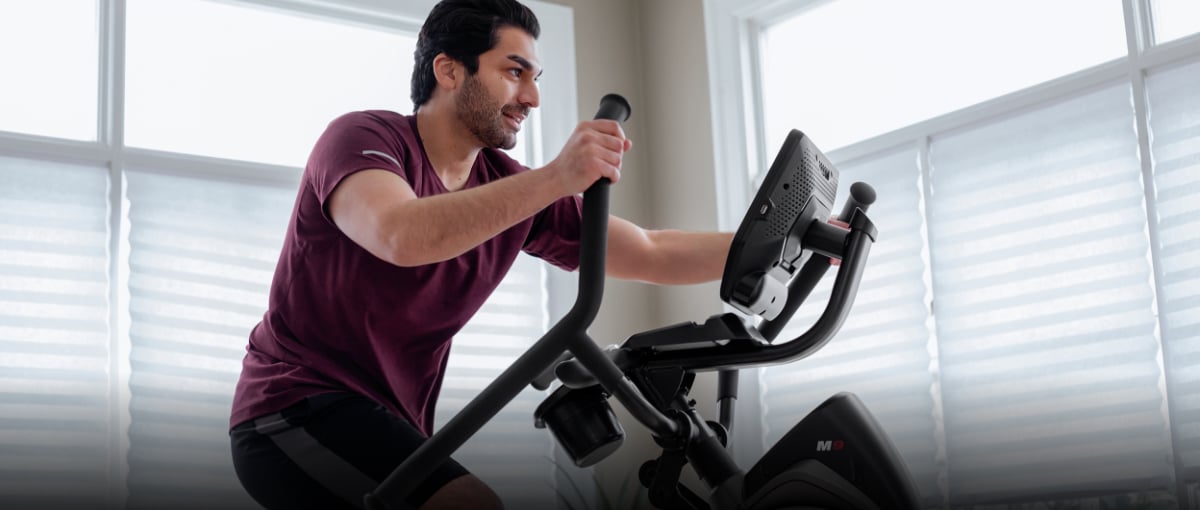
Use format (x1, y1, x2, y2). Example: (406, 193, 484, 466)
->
(0, 157, 118, 508)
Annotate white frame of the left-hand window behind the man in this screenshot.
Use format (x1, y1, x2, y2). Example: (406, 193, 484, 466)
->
(0, 0, 578, 508)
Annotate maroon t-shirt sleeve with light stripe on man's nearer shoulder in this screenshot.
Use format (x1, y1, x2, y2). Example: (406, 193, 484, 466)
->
(306, 112, 412, 218)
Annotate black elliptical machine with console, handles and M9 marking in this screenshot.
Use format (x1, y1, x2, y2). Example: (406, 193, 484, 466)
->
(364, 95, 919, 510)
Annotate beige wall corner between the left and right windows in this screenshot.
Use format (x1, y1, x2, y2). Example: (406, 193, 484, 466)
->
(551, 0, 721, 352)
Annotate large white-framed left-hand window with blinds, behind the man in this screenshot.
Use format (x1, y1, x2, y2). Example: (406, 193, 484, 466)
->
(0, 0, 576, 509)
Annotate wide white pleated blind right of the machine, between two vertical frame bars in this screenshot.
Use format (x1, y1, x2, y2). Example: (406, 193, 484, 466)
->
(929, 84, 1172, 504)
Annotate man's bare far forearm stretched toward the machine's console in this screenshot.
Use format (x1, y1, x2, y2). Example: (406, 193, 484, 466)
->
(605, 216, 733, 284)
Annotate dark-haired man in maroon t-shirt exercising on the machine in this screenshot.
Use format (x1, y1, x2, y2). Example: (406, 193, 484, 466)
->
(230, 0, 732, 509)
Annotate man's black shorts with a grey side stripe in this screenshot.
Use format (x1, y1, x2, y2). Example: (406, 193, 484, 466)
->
(229, 392, 468, 509)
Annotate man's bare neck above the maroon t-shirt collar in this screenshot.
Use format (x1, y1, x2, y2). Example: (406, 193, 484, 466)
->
(416, 105, 480, 191)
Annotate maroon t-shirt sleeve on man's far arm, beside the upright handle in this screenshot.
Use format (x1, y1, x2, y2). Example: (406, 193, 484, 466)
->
(523, 196, 583, 271)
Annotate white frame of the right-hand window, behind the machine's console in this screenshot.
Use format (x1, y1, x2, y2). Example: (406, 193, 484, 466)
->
(703, 0, 1200, 506)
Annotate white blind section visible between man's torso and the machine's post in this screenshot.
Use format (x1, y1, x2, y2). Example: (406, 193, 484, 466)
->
(436, 253, 556, 508)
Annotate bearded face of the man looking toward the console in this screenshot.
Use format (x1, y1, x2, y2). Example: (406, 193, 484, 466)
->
(455, 26, 541, 149)
